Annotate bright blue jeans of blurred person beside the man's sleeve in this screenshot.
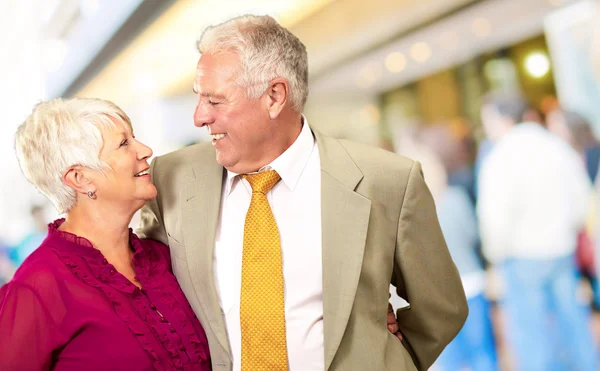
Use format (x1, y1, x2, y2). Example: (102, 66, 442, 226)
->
(435, 294, 498, 371)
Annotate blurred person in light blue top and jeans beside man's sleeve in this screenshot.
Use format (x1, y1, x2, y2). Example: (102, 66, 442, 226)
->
(398, 130, 498, 371)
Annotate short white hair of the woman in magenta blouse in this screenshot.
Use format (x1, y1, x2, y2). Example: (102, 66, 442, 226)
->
(15, 98, 131, 213)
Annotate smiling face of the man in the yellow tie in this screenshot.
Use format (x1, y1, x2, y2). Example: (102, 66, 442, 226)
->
(194, 53, 272, 173)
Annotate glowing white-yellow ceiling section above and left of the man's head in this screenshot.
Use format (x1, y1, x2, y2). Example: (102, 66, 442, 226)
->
(77, 0, 332, 105)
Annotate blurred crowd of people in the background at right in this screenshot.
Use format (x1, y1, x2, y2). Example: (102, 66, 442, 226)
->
(395, 91, 600, 371)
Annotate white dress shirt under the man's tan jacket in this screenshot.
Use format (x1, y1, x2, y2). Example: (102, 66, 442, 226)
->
(213, 117, 325, 371)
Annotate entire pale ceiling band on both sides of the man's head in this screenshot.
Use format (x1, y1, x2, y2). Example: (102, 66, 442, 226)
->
(77, 0, 573, 105)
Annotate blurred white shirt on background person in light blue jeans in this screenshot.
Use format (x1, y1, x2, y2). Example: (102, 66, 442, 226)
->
(477, 123, 591, 262)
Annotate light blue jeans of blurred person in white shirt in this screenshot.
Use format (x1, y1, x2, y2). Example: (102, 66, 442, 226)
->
(502, 256, 598, 371)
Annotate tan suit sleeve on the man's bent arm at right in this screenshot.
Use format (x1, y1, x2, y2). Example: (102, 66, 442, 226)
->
(392, 162, 468, 370)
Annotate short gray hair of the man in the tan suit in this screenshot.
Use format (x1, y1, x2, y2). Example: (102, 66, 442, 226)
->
(197, 15, 308, 112)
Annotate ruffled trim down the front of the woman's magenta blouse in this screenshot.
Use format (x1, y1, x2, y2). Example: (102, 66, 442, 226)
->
(47, 219, 210, 370)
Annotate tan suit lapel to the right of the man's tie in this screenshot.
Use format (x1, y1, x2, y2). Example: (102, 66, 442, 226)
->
(315, 133, 371, 370)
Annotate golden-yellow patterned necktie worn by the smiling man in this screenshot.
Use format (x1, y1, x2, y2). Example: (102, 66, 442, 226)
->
(240, 170, 288, 371)
